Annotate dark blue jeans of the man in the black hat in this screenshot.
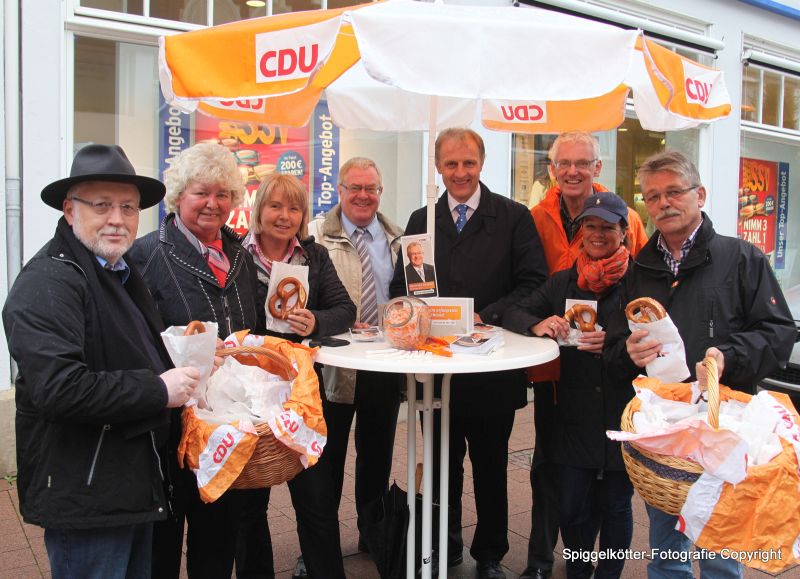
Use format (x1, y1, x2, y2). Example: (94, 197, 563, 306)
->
(44, 523, 153, 579)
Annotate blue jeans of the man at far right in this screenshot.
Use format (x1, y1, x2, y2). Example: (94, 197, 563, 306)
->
(646, 505, 742, 579)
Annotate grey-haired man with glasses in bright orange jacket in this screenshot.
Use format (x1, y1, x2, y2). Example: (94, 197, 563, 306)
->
(520, 131, 647, 579)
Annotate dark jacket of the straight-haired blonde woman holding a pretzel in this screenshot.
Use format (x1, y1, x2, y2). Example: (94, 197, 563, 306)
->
(247, 237, 356, 342)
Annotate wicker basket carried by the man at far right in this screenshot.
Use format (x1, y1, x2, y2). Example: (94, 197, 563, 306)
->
(621, 358, 719, 515)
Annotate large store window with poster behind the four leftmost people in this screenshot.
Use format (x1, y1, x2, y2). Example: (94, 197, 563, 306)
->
(73, 36, 423, 235)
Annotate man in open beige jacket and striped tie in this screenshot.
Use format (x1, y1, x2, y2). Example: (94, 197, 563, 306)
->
(309, 157, 403, 551)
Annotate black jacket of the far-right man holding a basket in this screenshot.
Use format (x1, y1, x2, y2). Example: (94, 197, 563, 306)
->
(604, 214, 797, 394)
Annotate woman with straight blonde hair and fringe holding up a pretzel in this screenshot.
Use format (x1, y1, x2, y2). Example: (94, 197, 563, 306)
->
(242, 173, 356, 579)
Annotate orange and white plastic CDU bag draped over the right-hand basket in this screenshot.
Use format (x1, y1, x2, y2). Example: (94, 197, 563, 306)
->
(612, 377, 800, 574)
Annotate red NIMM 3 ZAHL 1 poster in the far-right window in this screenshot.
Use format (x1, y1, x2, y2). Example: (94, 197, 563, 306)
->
(737, 157, 779, 263)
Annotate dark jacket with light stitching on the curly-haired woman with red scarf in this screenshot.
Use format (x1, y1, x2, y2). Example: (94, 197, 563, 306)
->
(130, 213, 265, 339)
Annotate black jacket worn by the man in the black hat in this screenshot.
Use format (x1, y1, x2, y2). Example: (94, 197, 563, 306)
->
(3, 218, 170, 529)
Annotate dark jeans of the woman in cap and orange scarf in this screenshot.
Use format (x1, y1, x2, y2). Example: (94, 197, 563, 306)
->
(559, 465, 633, 579)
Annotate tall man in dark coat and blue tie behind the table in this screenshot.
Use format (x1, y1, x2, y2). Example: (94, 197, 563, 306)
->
(391, 129, 547, 578)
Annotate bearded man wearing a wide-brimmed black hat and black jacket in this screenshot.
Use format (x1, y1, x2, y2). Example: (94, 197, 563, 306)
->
(3, 145, 199, 579)
